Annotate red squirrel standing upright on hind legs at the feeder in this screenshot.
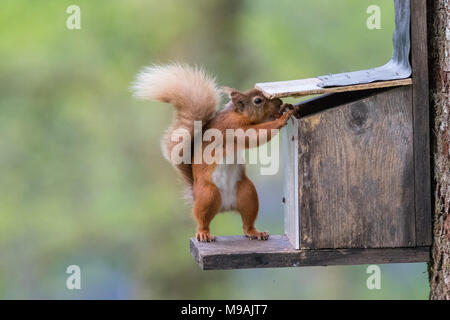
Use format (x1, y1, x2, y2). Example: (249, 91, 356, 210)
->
(132, 64, 294, 242)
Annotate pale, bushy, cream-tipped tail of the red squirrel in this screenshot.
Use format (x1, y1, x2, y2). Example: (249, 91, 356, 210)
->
(132, 63, 220, 198)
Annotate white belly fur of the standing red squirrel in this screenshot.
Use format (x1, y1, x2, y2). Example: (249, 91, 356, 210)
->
(212, 164, 244, 210)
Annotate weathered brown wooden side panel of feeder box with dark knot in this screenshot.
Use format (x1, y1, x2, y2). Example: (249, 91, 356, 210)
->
(298, 87, 416, 249)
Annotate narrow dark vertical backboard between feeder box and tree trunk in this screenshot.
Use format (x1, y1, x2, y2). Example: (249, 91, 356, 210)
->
(411, 0, 432, 246)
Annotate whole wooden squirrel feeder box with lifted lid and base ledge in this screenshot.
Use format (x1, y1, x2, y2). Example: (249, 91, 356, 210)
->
(190, 0, 431, 269)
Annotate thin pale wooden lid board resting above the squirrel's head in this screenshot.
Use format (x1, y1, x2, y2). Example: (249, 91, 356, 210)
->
(255, 78, 412, 99)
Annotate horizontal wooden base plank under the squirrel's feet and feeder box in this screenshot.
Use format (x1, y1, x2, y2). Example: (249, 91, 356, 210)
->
(190, 236, 430, 270)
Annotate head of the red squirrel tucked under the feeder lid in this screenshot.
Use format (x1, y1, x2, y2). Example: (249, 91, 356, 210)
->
(223, 88, 283, 123)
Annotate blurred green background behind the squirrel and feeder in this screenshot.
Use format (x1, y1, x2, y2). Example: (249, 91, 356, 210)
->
(0, 0, 428, 299)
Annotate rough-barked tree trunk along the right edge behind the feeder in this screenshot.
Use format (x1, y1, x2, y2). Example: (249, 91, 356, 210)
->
(428, 0, 450, 300)
